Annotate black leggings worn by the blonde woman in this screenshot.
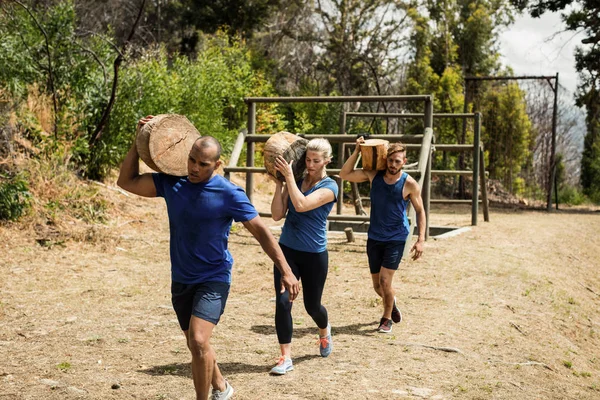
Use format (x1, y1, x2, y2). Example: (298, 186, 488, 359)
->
(273, 244, 329, 344)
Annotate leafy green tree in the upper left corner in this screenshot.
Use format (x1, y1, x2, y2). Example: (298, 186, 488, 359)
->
(0, 0, 114, 146)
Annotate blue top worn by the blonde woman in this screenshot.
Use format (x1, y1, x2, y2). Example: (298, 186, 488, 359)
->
(279, 177, 338, 253)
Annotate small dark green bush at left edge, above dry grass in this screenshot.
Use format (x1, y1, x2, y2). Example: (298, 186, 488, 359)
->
(0, 175, 31, 221)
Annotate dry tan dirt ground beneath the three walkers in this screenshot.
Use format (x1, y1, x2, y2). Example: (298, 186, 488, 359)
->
(0, 173, 600, 400)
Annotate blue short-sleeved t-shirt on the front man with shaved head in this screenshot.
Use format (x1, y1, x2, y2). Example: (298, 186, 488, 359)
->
(152, 173, 258, 285)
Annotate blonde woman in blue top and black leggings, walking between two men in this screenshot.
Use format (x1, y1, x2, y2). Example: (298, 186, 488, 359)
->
(271, 138, 338, 375)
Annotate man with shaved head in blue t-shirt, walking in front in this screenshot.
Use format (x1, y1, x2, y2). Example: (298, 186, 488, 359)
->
(117, 116, 299, 400)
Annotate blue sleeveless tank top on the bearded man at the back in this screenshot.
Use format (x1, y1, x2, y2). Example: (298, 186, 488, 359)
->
(368, 171, 410, 242)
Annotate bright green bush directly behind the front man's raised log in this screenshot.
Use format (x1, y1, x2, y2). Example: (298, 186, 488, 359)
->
(81, 33, 282, 179)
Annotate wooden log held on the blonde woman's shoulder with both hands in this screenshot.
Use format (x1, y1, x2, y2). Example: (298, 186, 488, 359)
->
(263, 132, 308, 182)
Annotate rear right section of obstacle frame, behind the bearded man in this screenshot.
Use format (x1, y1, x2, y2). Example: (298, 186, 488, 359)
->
(340, 112, 490, 225)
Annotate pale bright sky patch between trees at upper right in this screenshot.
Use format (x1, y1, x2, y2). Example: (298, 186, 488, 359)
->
(500, 13, 583, 93)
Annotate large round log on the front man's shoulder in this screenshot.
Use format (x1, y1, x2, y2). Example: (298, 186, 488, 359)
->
(136, 114, 200, 176)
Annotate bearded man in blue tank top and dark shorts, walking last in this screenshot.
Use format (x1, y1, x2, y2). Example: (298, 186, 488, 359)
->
(340, 137, 426, 333)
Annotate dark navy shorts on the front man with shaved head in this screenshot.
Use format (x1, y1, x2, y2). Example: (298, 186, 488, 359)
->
(171, 282, 230, 331)
